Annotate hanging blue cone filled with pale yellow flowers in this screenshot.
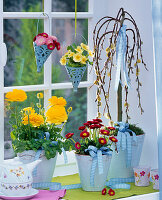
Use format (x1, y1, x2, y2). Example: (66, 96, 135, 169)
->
(60, 43, 93, 91)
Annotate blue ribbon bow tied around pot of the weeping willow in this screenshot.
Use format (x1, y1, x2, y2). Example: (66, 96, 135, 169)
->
(115, 122, 137, 167)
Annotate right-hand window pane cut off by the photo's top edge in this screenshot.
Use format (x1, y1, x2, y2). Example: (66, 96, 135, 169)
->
(52, 0, 88, 12)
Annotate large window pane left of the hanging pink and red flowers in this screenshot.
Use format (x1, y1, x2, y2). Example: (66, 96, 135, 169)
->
(4, 19, 43, 86)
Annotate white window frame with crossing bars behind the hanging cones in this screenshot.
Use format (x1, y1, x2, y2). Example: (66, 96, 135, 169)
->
(0, 0, 94, 163)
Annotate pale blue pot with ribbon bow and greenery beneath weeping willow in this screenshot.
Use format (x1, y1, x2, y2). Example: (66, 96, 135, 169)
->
(106, 123, 145, 179)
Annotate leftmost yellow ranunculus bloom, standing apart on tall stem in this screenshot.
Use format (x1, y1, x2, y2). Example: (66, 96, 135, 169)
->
(6, 89, 27, 102)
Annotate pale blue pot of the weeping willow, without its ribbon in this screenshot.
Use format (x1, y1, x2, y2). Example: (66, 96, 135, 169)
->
(108, 135, 144, 179)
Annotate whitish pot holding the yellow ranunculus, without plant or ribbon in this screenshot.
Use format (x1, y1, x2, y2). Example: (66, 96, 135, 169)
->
(17, 150, 57, 183)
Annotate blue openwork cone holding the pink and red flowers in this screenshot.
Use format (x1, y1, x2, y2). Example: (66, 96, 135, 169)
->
(33, 42, 53, 72)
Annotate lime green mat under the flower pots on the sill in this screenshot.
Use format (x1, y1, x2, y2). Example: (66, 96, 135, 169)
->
(53, 174, 158, 200)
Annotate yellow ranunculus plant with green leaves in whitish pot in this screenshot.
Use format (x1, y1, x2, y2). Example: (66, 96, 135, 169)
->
(6, 89, 72, 182)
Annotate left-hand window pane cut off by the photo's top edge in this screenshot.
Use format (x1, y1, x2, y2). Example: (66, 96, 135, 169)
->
(3, 0, 43, 12)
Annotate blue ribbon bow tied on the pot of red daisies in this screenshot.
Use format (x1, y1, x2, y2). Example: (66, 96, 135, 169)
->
(85, 145, 112, 186)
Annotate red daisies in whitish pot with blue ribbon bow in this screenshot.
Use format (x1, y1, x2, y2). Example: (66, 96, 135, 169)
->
(65, 119, 117, 191)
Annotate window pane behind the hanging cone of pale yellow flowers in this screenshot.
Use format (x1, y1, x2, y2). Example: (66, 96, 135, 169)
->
(52, 19, 88, 83)
